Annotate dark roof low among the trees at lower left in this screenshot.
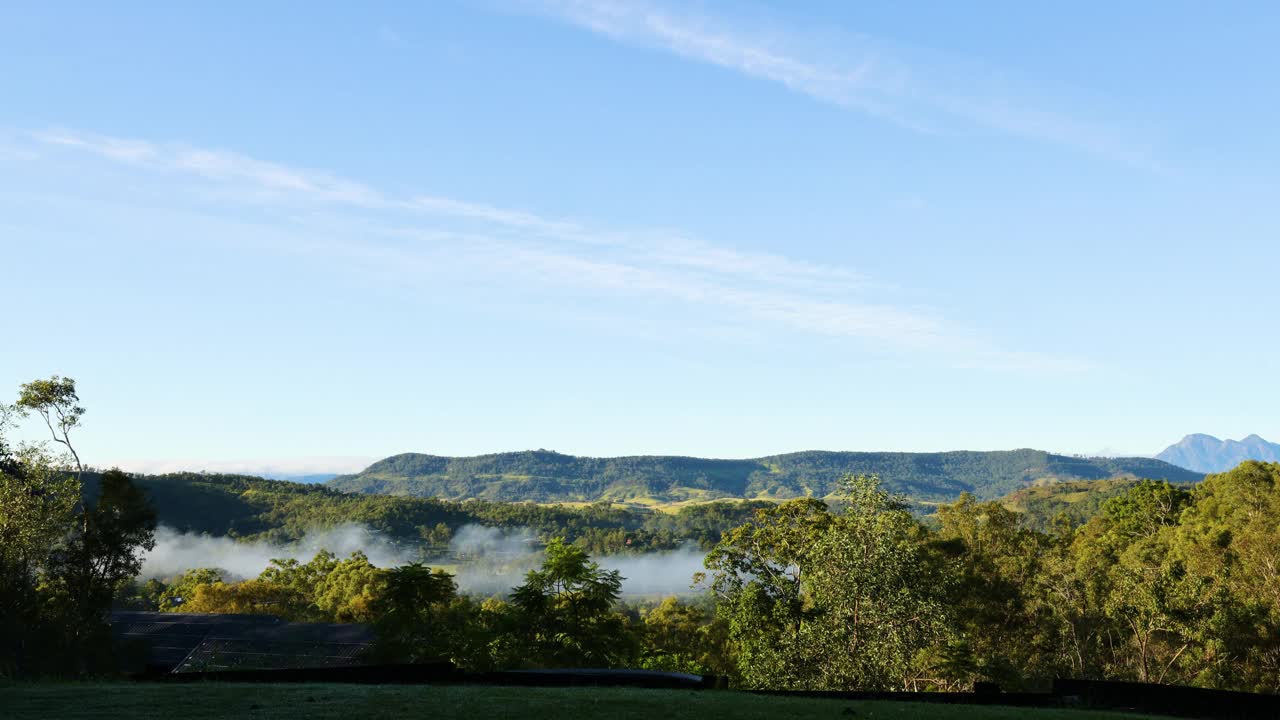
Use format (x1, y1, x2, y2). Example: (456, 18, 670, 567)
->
(111, 611, 374, 673)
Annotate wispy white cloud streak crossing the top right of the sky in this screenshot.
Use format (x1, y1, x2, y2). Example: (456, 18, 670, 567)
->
(532, 0, 1158, 163)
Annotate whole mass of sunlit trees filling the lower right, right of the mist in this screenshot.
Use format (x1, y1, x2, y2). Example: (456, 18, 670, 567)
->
(708, 462, 1280, 692)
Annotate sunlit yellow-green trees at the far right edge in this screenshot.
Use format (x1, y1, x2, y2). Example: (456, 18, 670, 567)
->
(993, 464, 1280, 691)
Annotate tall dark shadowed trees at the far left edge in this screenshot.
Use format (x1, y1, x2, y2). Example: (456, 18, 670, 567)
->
(0, 375, 156, 675)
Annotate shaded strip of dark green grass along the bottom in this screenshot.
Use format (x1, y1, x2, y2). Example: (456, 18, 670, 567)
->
(0, 683, 1149, 720)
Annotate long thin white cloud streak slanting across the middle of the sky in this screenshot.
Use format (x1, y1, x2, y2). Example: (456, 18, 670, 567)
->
(17, 129, 1088, 373)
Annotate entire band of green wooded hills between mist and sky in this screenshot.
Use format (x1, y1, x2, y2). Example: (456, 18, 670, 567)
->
(86, 451, 1201, 553)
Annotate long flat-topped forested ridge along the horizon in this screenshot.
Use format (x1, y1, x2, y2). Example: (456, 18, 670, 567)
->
(328, 450, 1203, 502)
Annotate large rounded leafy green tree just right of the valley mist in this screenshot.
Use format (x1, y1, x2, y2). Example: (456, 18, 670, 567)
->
(707, 477, 943, 689)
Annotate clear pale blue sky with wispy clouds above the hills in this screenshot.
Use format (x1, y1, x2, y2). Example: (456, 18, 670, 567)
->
(0, 0, 1280, 473)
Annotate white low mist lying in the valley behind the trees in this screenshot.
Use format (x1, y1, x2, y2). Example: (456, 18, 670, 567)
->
(142, 524, 705, 596)
